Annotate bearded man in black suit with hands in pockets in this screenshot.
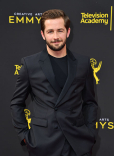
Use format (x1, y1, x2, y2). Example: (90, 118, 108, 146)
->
(11, 9, 97, 156)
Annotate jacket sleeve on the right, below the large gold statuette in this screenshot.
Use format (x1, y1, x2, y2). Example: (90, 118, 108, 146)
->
(82, 60, 98, 139)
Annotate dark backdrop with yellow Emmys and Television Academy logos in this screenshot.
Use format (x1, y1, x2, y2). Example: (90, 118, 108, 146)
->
(0, 0, 114, 156)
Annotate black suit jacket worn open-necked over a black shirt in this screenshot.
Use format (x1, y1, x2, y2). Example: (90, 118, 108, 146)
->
(11, 49, 98, 156)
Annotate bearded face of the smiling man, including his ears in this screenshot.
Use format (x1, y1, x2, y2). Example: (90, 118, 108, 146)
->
(41, 18, 70, 51)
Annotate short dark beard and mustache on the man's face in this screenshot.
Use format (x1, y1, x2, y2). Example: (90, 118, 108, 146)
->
(45, 38, 67, 51)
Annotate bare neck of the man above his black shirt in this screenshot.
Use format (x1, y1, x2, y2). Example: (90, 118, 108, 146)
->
(47, 45, 67, 58)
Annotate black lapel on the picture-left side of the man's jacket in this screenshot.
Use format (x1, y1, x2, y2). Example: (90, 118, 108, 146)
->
(39, 48, 61, 94)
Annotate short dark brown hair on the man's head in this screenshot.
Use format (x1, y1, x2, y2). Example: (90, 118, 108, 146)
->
(40, 9, 70, 32)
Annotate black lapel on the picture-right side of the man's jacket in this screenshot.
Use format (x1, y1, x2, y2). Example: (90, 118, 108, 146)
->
(55, 49, 77, 105)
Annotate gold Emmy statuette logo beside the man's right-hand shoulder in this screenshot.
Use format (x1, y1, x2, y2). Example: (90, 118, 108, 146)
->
(90, 58, 102, 84)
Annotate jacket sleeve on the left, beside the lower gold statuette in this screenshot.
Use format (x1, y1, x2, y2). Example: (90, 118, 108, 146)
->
(10, 58, 30, 145)
